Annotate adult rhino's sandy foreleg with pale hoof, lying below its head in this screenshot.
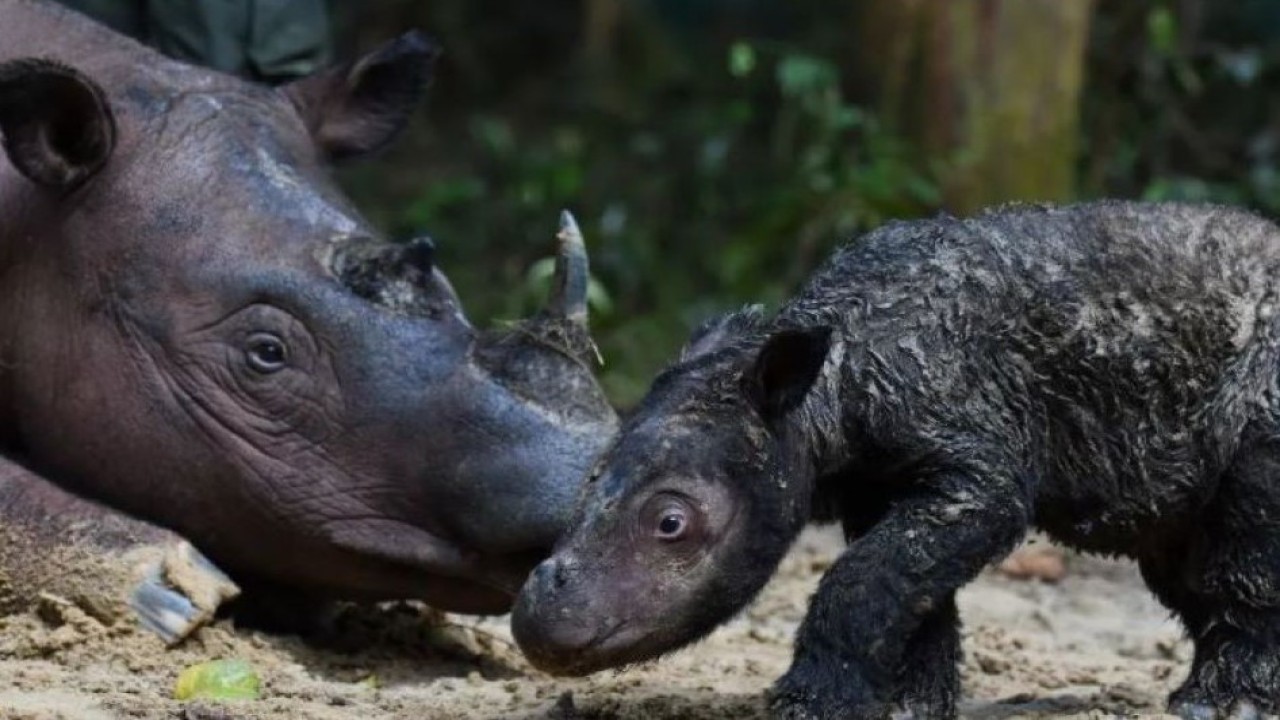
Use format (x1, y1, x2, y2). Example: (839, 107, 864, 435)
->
(0, 457, 239, 643)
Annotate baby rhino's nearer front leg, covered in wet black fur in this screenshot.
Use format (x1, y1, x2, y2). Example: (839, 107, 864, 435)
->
(769, 471, 1029, 720)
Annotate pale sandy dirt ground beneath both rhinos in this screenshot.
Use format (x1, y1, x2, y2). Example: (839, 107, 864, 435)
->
(0, 520, 1190, 720)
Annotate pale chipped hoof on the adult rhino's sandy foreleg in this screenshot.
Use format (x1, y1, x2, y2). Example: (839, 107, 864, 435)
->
(129, 542, 239, 646)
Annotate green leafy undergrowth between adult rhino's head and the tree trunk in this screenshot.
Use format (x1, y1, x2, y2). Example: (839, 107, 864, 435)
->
(350, 35, 937, 405)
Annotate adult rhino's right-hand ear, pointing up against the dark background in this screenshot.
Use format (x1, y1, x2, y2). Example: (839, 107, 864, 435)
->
(282, 31, 439, 160)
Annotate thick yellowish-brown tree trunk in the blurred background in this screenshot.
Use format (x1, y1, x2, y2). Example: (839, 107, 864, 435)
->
(858, 0, 1093, 213)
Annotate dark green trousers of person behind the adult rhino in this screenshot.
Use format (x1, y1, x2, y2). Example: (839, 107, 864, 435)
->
(59, 0, 333, 83)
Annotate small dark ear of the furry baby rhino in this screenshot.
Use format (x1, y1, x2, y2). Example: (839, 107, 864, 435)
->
(742, 327, 832, 421)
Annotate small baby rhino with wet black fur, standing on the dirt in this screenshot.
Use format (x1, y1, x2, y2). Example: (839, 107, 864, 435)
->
(515, 202, 1280, 719)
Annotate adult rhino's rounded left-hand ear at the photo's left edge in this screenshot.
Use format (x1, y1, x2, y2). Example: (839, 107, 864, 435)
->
(0, 59, 115, 191)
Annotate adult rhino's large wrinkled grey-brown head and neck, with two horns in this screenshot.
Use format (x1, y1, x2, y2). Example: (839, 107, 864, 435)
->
(0, 0, 616, 625)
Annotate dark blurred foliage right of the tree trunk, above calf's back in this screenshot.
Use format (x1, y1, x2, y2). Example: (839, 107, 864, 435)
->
(1082, 0, 1280, 213)
